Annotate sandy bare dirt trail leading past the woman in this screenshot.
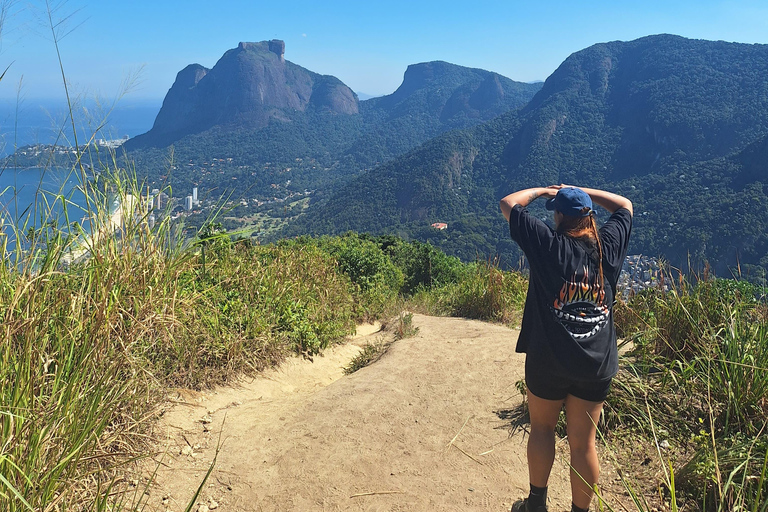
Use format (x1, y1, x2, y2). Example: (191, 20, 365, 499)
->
(149, 315, 632, 512)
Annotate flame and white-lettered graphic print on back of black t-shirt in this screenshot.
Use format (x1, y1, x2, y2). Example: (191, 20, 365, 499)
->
(552, 267, 609, 340)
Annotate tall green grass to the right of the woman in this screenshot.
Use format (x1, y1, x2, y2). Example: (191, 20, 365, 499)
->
(608, 275, 768, 511)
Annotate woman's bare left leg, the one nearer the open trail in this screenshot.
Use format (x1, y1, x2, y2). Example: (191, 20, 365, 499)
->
(528, 391, 563, 487)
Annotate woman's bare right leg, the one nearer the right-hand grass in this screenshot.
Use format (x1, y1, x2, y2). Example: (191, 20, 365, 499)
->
(565, 395, 603, 509)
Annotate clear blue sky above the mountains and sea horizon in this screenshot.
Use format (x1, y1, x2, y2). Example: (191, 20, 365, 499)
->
(0, 0, 768, 104)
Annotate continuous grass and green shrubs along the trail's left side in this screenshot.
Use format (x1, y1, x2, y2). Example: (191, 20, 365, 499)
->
(0, 165, 528, 510)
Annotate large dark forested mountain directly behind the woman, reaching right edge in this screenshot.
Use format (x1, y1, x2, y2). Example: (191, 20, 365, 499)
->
(291, 35, 768, 273)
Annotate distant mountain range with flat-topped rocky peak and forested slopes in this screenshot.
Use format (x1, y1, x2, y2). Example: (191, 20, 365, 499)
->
(125, 40, 542, 198)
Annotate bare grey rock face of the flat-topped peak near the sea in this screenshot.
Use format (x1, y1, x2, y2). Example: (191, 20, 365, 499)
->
(129, 40, 358, 148)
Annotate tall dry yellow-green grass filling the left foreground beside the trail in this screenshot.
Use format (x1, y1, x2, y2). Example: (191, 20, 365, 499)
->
(0, 160, 180, 510)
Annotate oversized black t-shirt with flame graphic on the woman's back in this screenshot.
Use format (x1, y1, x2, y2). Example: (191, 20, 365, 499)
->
(509, 205, 632, 382)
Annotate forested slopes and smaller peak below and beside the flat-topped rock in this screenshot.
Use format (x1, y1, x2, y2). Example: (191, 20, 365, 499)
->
(105, 62, 541, 204)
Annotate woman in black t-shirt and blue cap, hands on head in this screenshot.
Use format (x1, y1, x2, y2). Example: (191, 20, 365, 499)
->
(500, 185, 632, 512)
